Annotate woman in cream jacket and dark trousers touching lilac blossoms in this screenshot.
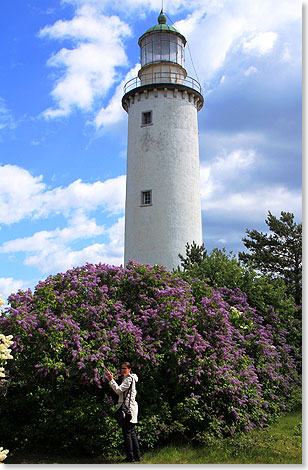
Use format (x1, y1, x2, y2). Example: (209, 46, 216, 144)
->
(107, 362, 140, 462)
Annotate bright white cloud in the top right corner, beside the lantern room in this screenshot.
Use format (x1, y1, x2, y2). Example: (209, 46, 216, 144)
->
(175, 0, 301, 83)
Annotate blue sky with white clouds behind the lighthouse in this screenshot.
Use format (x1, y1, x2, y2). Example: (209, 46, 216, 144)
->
(0, 0, 302, 298)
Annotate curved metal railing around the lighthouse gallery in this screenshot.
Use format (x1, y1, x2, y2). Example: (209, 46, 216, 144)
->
(124, 72, 202, 94)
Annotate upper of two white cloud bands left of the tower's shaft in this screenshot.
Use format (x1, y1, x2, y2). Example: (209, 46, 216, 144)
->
(0, 165, 126, 224)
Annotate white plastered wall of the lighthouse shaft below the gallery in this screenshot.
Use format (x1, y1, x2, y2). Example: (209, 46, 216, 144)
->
(124, 89, 202, 269)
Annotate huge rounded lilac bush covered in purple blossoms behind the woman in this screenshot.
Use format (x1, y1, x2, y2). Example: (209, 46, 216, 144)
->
(0, 263, 300, 454)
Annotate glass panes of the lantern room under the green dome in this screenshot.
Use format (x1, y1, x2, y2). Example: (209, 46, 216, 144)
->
(140, 32, 184, 67)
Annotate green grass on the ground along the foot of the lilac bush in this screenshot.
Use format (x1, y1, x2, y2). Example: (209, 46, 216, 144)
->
(5, 412, 302, 464)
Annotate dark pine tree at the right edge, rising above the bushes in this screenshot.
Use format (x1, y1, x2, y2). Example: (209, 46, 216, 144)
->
(239, 211, 302, 304)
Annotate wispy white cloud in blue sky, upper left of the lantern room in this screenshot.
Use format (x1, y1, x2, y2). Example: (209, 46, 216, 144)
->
(40, 4, 131, 118)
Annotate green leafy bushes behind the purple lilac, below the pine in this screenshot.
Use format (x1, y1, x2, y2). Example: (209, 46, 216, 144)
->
(177, 244, 302, 371)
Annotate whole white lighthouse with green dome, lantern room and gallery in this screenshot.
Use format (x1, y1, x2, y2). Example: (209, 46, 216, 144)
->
(122, 12, 203, 270)
